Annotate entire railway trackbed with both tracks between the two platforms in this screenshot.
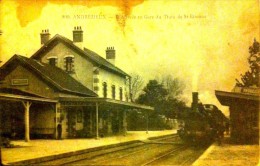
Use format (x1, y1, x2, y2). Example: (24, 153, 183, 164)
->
(10, 134, 206, 166)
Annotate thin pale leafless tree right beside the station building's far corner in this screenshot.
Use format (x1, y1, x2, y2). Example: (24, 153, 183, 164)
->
(130, 73, 144, 101)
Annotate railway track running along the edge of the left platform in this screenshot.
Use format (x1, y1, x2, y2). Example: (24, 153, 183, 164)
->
(18, 134, 178, 165)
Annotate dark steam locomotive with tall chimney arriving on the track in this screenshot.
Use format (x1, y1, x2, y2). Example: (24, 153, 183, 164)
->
(178, 92, 227, 144)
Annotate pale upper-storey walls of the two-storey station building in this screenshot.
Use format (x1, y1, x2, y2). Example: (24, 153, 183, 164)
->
(41, 43, 129, 101)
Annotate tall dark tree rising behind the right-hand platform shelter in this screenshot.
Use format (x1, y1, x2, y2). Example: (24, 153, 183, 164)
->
(236, 39, 260, 87)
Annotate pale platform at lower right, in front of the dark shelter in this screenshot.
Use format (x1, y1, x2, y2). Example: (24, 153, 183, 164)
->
(192, 136, 260, 166)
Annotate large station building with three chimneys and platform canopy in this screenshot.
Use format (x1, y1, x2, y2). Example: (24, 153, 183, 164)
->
(0, 27, 153, 141)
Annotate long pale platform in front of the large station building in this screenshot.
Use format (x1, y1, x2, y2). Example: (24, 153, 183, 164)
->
(1, 130, 177, 165)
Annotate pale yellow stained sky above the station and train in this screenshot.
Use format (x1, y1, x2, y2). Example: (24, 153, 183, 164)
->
(0, 0, 260, 115)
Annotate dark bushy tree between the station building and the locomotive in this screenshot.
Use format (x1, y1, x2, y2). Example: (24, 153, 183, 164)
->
(135, 78, 186, 129)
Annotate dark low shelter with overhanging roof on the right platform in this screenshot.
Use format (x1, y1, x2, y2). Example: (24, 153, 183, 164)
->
(215, 86, 260, 144)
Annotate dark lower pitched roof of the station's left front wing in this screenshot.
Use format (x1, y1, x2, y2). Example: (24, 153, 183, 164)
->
(2, 55, 97, 97)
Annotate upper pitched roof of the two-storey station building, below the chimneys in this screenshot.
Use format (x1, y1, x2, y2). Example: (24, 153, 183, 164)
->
(31, 34, 130, 77)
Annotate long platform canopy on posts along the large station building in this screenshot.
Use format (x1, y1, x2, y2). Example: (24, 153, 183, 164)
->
(0, 88, 154, 142)
